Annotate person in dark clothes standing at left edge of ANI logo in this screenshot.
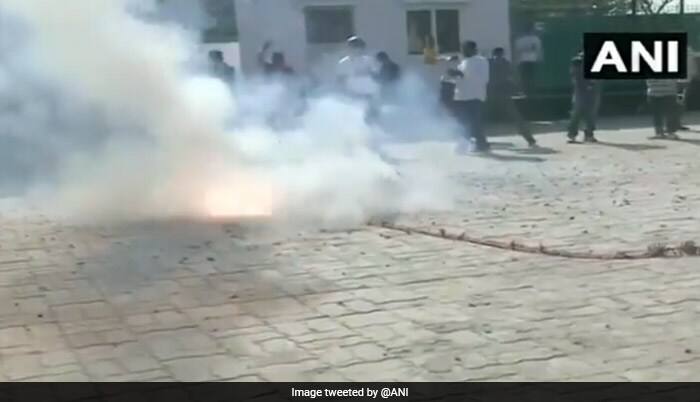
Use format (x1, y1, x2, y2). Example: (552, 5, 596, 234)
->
(567, 56, 598, 144)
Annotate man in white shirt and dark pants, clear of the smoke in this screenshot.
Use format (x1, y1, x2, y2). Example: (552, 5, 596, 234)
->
(451, 41, 489, 152)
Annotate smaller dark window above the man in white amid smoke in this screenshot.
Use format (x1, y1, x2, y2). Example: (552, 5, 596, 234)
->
(304, 6, 355, 44)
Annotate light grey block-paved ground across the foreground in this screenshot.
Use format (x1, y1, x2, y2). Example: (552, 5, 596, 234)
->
(0, 115, 700, 381)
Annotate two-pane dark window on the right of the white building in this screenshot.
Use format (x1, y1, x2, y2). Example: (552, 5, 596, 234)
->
(406, 9, 460, 54)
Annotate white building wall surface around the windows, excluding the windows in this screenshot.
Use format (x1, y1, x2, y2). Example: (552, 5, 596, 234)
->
(232, 0, 510, 80)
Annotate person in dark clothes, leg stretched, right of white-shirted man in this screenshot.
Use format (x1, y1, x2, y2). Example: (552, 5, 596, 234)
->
(486, 47, 537, 147)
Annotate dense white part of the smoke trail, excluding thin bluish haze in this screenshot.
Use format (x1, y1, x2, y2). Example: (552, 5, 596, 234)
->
(0, 0, 454, 223)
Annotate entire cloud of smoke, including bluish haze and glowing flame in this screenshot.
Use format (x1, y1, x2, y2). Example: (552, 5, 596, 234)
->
(0, 0, 451, 228)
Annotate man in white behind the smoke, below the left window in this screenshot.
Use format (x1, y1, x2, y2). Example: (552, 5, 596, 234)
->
(338, 36, 380, 121)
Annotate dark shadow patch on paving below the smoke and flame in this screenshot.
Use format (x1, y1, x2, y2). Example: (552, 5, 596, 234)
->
(56, 220, 340, 310)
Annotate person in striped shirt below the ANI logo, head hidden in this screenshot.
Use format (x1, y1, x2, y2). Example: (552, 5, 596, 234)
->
(647, 79, 679, 140)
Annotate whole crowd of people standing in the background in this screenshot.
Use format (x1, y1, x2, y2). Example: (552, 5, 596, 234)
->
(210, 34, 696, 152)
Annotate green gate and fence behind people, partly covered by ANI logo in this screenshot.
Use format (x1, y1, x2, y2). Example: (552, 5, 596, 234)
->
(510, 0, 700, 115)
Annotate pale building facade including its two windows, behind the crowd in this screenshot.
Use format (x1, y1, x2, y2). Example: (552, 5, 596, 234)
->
(230, 0, 511, 79)
